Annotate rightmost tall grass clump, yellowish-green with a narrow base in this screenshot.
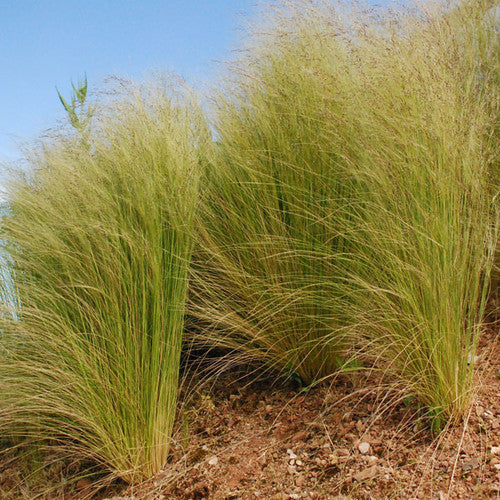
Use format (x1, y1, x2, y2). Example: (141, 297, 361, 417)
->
(344, 2, 499, 427)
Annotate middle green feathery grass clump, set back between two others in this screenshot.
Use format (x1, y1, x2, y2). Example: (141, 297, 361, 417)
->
(191, 4, 366, 384)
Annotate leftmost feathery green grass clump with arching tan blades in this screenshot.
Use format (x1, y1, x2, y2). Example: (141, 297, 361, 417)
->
(0, 81, 208, 482)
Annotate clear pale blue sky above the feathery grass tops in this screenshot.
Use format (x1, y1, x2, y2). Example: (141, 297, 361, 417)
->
(0, 0, 398, 163)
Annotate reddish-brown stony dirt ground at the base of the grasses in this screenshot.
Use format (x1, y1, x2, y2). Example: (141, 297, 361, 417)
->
(0, 327, 500, 500)
